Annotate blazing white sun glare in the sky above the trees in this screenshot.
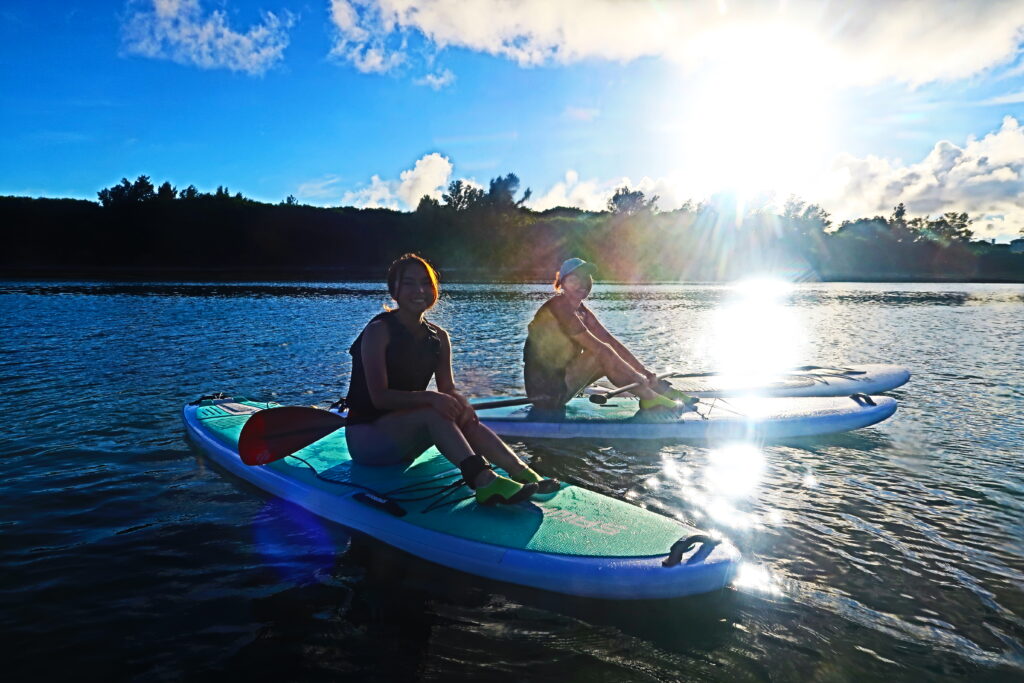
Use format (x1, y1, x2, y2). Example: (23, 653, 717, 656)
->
(679, 25, 835, 197)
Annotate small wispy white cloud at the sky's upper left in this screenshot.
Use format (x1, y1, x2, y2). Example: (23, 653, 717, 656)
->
(122, 0, 293, 75)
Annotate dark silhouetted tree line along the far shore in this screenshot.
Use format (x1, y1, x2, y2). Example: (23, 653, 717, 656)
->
(0, 173, 1024, 282)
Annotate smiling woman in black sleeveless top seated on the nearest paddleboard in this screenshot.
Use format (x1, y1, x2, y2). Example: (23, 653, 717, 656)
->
(345, 254, 558, 505)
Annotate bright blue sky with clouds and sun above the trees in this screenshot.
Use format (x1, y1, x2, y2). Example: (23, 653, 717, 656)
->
(0, 0, 1024, 240)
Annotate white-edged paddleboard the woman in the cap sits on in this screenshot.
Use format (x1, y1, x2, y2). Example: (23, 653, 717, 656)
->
(477, 394, 896, 441)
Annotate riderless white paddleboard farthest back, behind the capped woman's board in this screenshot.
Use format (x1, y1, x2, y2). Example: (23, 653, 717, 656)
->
(651, 364, 910, 398)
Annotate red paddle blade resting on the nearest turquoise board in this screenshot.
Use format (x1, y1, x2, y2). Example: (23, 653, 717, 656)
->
(239, 405, 345, 465)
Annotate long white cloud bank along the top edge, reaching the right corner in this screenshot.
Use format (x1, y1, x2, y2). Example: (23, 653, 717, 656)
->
(321, 0, 1024, 84)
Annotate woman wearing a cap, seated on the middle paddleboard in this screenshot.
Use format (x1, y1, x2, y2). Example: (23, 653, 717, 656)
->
(523, 258, 680, 414)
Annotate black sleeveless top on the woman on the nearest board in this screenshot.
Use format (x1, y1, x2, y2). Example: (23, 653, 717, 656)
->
(347, 312, 441, 425)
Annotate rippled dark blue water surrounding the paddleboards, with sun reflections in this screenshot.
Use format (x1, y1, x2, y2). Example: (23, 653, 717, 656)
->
(0, 283, 1024, 681)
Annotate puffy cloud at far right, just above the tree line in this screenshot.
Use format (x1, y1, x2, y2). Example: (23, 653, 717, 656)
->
(819, 117, 1024, 237)
